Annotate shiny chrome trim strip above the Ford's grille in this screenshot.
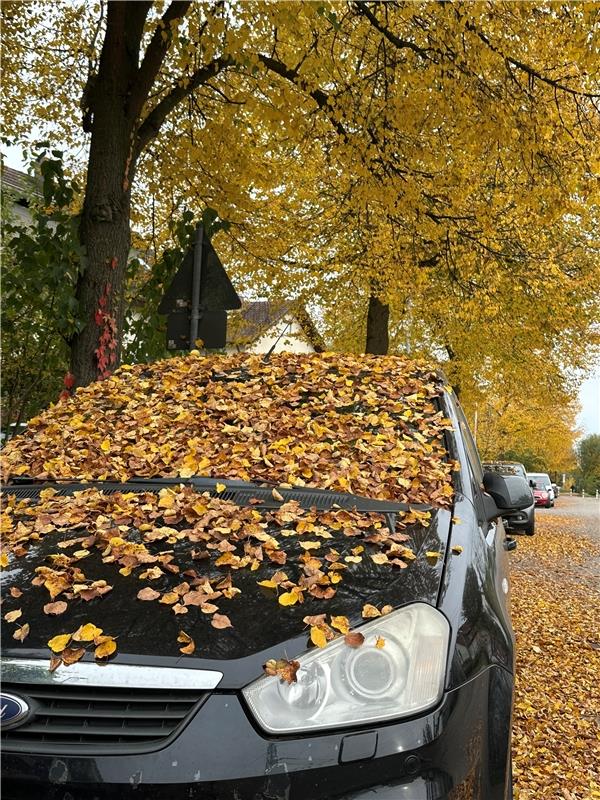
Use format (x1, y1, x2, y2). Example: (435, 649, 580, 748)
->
(2, 658, 223, 689)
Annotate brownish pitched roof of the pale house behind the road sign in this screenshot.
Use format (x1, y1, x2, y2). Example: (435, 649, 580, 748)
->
(227, 300, 326, 353)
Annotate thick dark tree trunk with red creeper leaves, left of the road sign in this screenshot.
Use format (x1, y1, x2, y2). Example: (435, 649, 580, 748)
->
(70, 2, 147, 386)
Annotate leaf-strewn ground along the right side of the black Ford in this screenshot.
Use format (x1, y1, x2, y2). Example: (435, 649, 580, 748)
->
(511, 500, 600, 800)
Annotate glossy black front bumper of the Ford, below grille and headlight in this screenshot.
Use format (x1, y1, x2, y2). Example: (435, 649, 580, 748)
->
(2, 667, 513, 800)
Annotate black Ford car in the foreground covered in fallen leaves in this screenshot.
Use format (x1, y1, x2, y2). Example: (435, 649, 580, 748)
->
(0, 353, 531, 800)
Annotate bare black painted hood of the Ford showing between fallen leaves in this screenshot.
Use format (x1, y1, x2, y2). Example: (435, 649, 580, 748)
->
(2, 488, 451, 688)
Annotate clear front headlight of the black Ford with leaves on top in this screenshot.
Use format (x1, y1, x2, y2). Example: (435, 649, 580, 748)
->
(243, 603, 450, 733)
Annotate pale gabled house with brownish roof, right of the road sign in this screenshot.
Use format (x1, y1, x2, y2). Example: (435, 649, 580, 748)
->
(226, 300, 326, 353)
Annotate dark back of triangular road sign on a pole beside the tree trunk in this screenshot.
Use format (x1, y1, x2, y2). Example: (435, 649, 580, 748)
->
(158, 224, 242, 350)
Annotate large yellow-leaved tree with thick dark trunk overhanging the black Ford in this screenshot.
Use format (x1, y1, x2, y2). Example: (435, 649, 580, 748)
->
(5, 2, 598, 390)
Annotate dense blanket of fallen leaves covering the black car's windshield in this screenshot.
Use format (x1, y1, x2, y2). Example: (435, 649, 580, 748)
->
(2, 354, 453, 506)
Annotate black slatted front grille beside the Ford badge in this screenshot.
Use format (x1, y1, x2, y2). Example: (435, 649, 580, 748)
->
(2, 682, 210, 753)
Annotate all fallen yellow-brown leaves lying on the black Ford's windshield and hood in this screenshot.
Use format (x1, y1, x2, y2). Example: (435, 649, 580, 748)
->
(2, 354, 454, 666)
